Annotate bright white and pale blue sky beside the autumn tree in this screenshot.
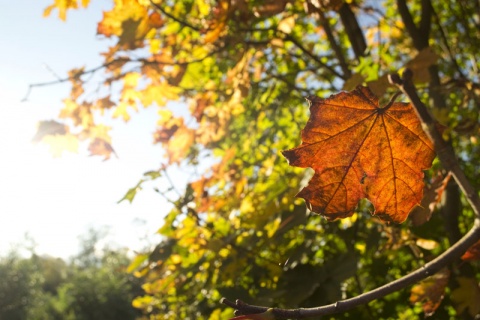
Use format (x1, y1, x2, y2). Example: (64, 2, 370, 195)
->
(0, 0, 178, 258)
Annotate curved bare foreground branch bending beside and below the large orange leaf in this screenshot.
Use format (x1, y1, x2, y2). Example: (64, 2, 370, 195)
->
(221, 70, 480, 319)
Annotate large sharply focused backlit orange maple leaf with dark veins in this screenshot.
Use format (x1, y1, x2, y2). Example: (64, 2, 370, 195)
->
(283, 86, 435, 223)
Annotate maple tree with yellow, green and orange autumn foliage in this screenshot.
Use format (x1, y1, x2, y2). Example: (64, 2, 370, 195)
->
(31, 0, 480, 319)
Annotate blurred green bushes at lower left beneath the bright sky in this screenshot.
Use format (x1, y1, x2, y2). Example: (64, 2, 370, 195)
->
(0, 229, 143, 320)
